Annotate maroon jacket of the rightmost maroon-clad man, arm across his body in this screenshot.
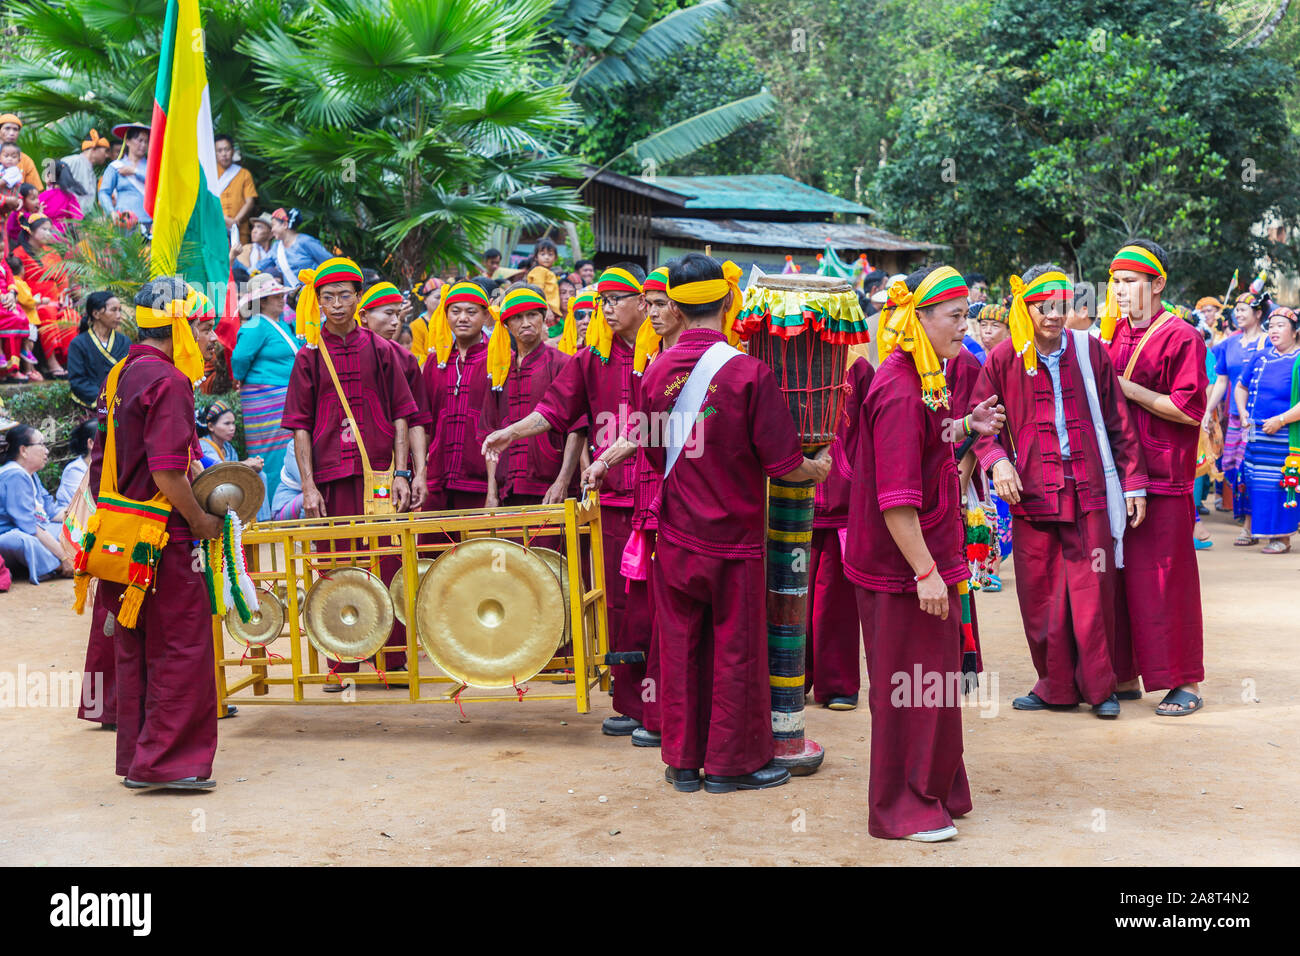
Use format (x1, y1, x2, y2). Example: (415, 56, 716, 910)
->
(1110, 312, 1209, 494)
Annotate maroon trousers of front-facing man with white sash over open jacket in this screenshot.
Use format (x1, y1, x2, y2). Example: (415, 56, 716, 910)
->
(1013, 481, 1115, 704)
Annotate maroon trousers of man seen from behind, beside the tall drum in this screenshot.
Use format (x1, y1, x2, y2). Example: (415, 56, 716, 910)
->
(650, 538, 774, 777)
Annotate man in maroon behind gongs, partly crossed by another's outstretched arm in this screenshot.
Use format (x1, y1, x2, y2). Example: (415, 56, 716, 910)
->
(480, 285, 586, 507)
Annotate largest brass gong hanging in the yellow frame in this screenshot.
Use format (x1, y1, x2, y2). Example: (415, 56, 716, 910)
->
(415, 538, 564, 688)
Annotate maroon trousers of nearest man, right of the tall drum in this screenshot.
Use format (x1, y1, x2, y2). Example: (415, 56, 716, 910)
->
(857, 587, 972, 839)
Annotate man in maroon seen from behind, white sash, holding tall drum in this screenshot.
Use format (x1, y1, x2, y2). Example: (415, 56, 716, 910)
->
(644, 252, 831, 793)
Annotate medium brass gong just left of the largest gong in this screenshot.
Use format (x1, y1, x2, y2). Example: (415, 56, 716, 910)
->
(304, 567, 393, 661)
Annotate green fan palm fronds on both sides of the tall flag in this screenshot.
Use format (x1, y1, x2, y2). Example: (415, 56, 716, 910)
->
(0, 0, 582, 281)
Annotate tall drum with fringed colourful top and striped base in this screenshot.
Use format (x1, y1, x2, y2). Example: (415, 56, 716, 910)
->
(738, 274, 870, 777)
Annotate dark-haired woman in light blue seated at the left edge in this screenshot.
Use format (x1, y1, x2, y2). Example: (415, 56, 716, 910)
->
(0, 425, 73, 584)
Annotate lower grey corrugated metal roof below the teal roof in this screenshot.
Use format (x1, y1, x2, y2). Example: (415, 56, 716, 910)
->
(650, 218, 948, 252)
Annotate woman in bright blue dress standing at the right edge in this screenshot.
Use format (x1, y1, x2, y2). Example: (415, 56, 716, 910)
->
(1235, 308, 1300, 554)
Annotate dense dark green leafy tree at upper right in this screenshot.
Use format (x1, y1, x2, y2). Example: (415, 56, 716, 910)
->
(872, 0, 1300, 294)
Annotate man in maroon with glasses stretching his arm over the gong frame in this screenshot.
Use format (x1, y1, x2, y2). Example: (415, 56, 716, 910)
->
(482, 263, 650, 736)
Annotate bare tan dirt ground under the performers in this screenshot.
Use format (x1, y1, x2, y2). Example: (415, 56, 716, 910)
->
(0, 515, 1300, 866)
